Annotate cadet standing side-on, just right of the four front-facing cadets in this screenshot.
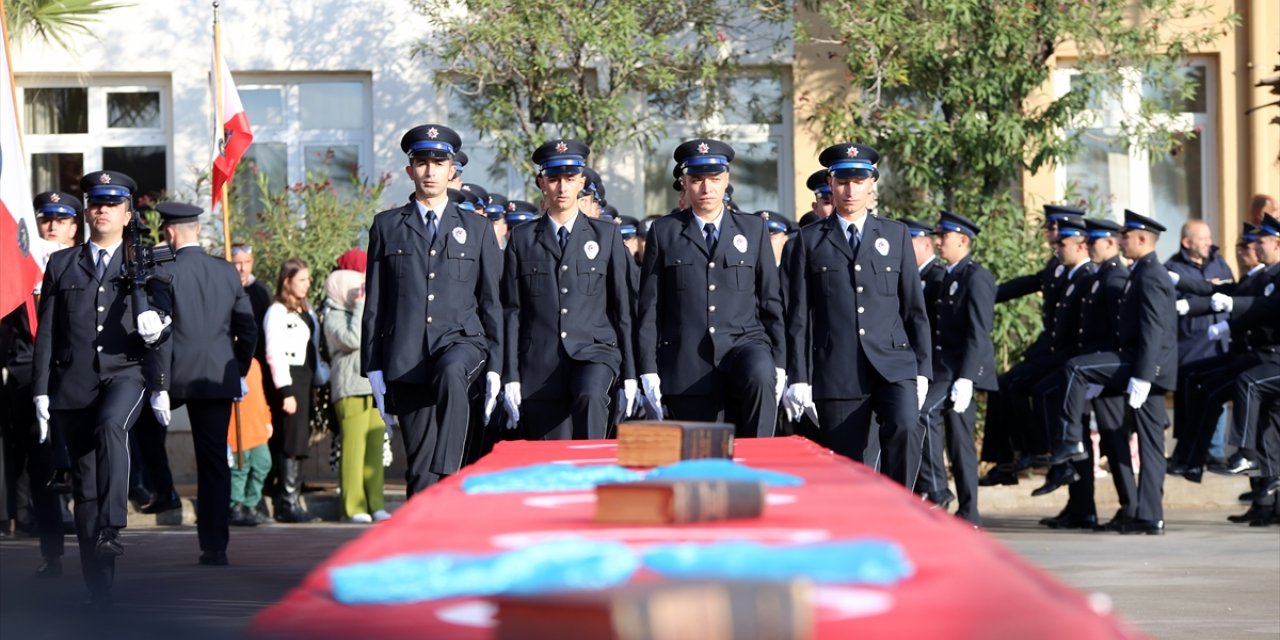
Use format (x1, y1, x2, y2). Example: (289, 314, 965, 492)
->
(920, 211, 996, 525)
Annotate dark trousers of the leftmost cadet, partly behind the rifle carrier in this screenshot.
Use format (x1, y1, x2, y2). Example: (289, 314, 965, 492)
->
(0, 384, 64, 558)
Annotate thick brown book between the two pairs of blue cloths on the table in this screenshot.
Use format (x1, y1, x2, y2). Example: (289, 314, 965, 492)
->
(595, 480, 765, 525)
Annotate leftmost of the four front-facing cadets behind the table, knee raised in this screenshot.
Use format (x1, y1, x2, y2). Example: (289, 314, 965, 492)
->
(360, 124, 502, 497)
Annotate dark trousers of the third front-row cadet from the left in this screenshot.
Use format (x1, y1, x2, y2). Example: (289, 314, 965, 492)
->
(662, 343, 778, 438)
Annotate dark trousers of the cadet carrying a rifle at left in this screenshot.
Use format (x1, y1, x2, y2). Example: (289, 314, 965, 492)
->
(50, 376, 147, 594)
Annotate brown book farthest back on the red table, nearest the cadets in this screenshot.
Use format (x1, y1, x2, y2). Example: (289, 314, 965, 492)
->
(618, 420, 733, 467)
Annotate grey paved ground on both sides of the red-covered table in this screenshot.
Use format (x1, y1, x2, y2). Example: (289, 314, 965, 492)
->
(0, 511, 1280, 640)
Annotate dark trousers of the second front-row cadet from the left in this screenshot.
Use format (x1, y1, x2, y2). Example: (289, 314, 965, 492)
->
(520, 360, 614, 440)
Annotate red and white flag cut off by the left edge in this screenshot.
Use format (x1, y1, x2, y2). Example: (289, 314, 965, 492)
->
(0, 17, 44, 332)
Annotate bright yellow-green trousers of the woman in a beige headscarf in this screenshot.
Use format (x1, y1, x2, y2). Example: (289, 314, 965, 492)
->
(334, 396, 387, 517)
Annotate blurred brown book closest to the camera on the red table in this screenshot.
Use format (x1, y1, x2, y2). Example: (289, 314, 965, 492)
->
(494, 580, 814, 640)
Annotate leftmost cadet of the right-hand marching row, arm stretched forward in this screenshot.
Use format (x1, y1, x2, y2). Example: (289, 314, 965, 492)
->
(978, 205, 1084, 486)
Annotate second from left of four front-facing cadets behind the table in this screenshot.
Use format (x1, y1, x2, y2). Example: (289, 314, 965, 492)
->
(502, 140, 636, 440)
